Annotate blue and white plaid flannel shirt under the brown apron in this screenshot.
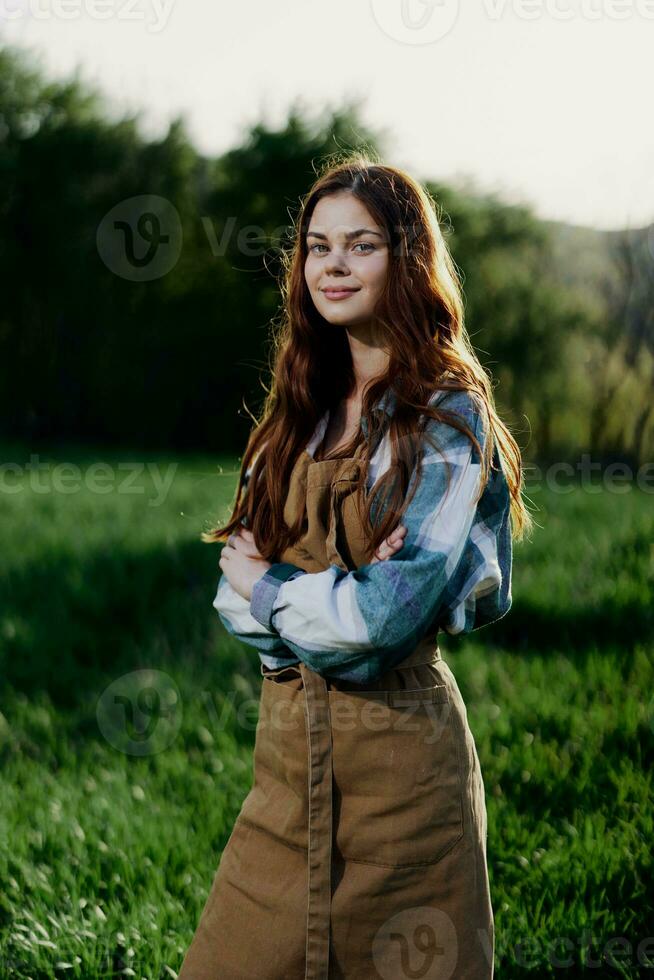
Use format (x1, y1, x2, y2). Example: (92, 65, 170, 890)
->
(213, 389, 512, 684)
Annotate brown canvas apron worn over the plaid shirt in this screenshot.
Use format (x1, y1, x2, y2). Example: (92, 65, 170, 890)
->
(179, 450, 495, 980)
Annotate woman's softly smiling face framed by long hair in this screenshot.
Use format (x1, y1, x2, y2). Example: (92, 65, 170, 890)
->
(304, 191, 389, 328)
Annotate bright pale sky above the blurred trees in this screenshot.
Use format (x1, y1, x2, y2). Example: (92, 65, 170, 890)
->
(0, 0, 654, 228)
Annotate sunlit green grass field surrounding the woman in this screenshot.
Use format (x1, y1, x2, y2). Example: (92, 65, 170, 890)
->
(0, 446, 654, 980)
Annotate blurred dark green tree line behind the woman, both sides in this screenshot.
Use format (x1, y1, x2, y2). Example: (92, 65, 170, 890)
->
(0, 47, 654, 465)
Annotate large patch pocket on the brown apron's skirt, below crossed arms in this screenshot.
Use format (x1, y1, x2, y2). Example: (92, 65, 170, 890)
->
(329, 675, 464, 868)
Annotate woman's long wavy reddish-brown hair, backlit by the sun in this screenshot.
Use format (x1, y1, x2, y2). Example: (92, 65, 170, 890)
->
(201, 154, 533, 562)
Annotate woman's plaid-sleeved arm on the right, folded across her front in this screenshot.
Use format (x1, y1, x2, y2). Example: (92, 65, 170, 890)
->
(214, 401, 499, 681)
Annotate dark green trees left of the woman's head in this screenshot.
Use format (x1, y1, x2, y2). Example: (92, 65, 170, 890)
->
(0, 50, 382, 450)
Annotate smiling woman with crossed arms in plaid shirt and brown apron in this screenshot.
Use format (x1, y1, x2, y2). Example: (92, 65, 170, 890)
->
(179, 157, 531, 980)
